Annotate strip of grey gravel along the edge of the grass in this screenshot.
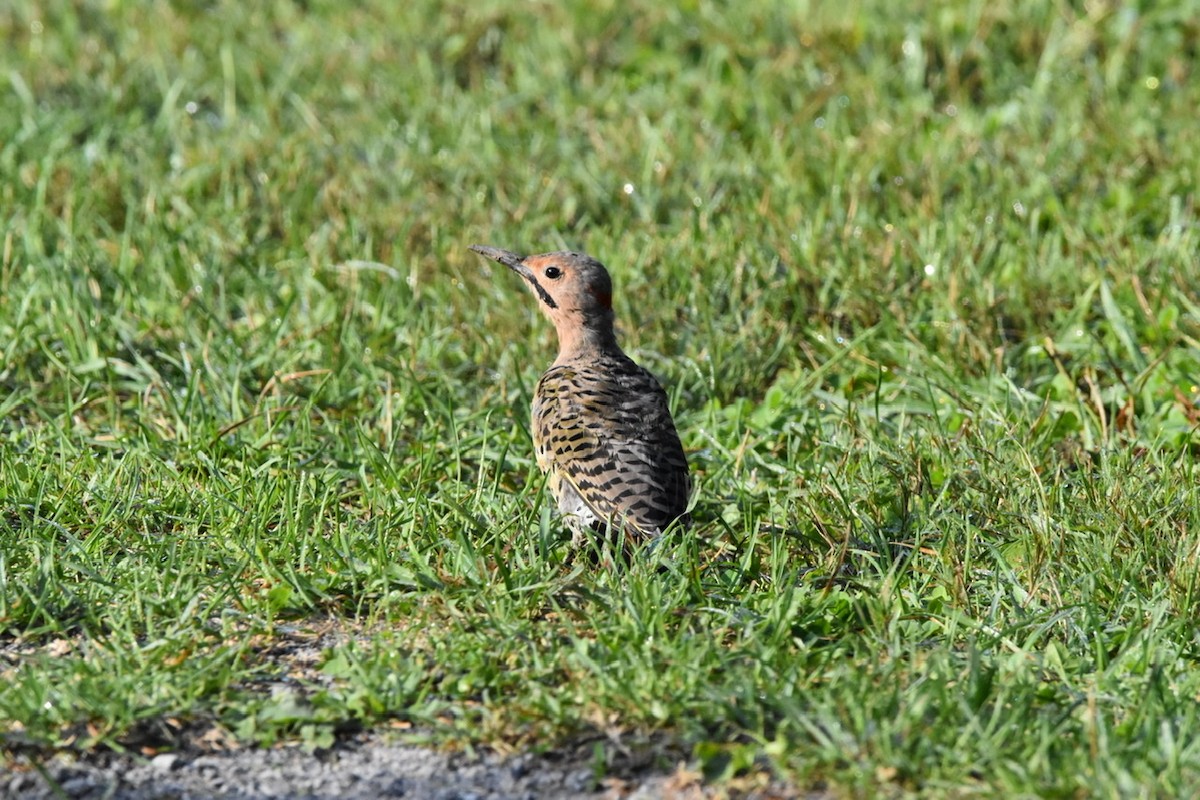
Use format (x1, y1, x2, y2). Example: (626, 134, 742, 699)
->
(0, 735, 797, 800)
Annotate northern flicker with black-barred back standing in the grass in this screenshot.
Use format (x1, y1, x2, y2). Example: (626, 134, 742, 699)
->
(470, 245, 691, 545)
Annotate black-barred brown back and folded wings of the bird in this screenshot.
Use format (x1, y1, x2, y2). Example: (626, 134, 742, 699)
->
(534, 362, 690, 535)
